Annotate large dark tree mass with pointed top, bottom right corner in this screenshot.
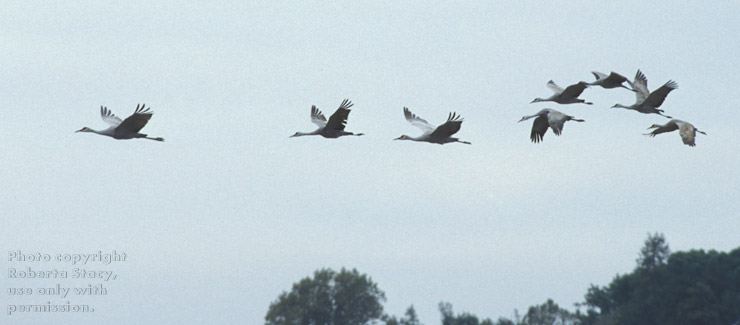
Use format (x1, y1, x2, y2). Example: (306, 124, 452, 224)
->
(579, 234, 740, 325)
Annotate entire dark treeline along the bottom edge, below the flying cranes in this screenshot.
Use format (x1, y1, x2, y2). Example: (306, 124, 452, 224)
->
(265, 233, 740, 325)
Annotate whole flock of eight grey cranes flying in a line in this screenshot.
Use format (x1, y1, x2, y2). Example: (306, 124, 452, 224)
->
(77, 70, 706, 147)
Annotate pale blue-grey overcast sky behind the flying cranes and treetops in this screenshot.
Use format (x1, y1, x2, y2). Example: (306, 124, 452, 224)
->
(0, 1, 740, 325)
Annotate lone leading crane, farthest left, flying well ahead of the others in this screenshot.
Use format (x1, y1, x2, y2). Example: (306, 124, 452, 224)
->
(75, 104, 164, 141)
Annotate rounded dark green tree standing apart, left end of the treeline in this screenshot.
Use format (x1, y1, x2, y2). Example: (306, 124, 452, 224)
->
(265, 268, 385, 325)
